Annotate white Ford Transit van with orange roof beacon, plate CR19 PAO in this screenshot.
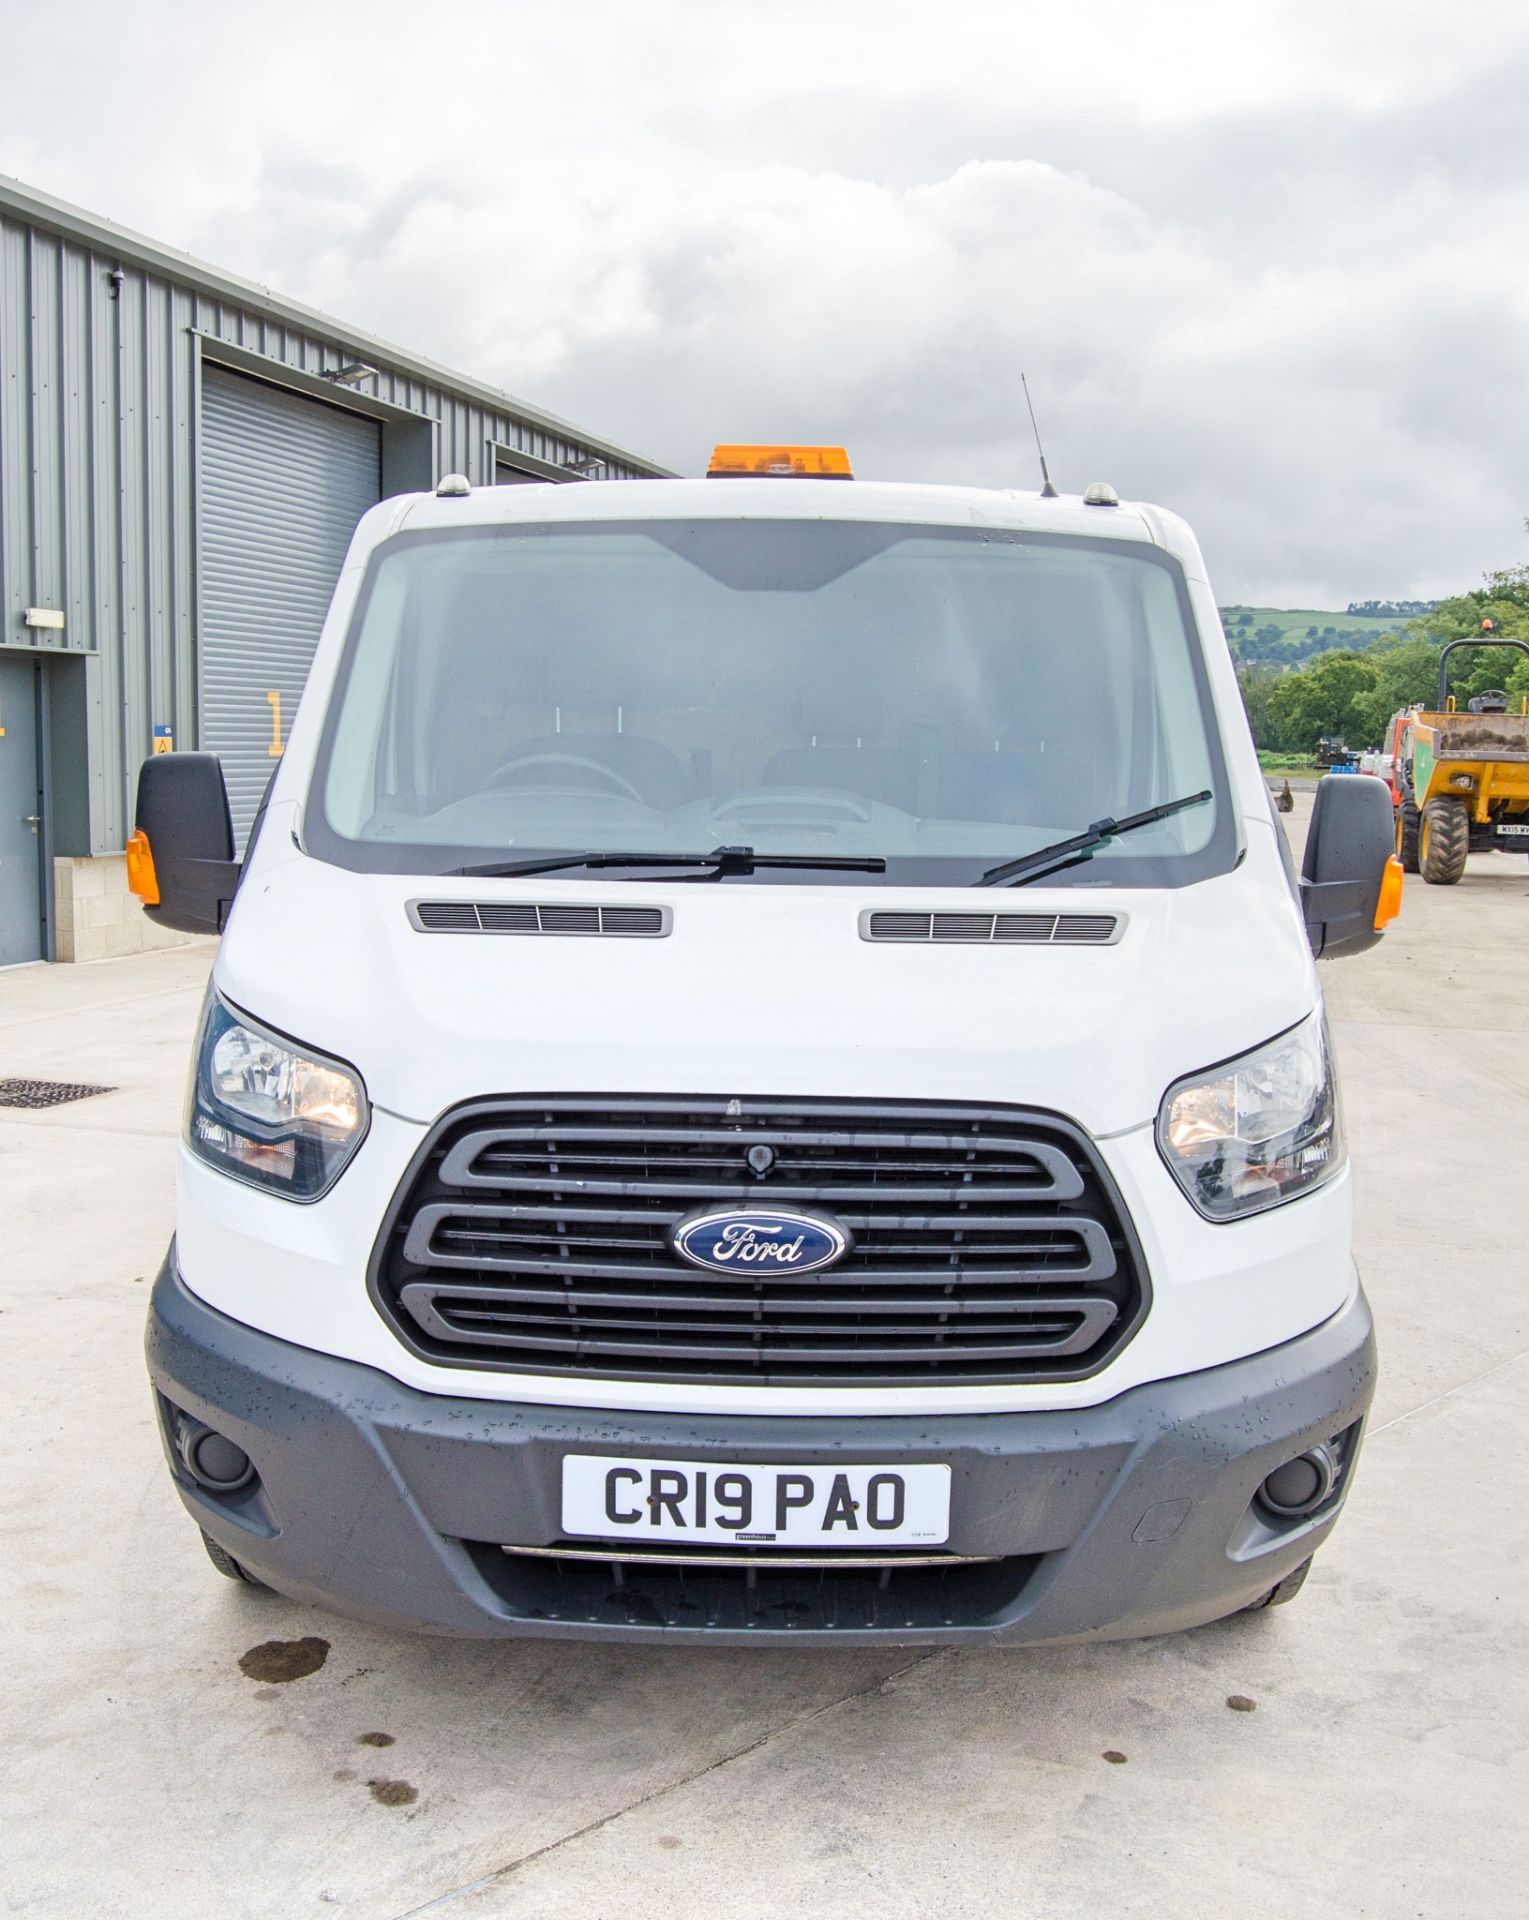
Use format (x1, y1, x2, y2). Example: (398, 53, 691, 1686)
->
(131, 449, 1398, 1644)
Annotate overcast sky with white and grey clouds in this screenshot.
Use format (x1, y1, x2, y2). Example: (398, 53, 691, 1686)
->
(0, 0, 1529, 607)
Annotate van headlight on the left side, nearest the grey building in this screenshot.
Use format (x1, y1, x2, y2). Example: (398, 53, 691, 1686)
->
(186, 993, 371, 1200)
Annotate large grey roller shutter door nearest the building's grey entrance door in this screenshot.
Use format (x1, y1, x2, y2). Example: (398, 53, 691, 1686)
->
(200, 367, 382, 847)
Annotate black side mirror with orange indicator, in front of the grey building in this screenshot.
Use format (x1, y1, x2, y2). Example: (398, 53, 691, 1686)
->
(127, 753, 238, 933)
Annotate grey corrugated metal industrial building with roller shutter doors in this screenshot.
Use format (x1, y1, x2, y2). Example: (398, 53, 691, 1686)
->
(0, 179, 665, 966)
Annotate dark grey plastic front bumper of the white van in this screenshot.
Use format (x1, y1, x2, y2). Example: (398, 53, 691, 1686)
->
(148, 1248, 1375, 1645)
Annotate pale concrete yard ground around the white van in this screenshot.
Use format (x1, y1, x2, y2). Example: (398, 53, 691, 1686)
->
(0, 797, 1529, 1920)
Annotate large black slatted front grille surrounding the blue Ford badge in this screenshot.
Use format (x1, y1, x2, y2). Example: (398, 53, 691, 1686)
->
(373, 1096, 1145, 1386)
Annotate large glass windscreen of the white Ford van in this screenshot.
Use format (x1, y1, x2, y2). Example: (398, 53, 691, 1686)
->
(307, 518, 1231, 885)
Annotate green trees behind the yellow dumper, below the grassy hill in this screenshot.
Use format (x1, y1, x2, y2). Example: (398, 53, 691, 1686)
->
(1237, 564, 1529, 753)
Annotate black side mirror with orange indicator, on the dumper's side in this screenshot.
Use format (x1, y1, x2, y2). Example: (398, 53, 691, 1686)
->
(1300, 774, 1402, 960)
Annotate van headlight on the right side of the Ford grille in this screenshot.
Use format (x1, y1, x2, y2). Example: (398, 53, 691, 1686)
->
(1158, 1012, 1343, 1221)
